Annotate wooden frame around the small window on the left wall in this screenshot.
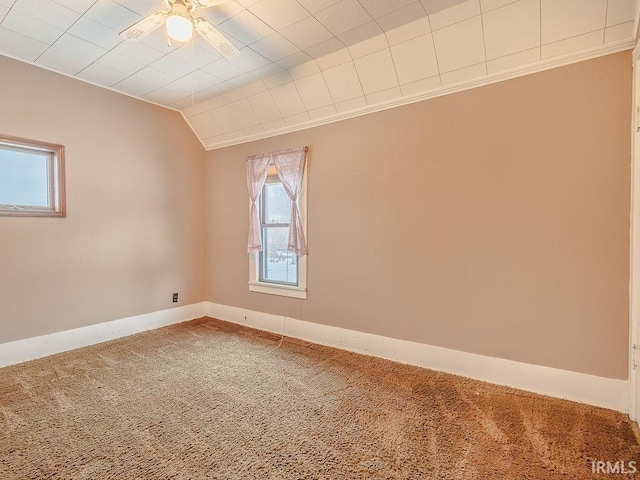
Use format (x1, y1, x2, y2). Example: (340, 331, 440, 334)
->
(0, 135, 67, 218)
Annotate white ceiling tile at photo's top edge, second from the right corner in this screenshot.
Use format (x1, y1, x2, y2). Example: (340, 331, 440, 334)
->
(541, 0, 607, 44)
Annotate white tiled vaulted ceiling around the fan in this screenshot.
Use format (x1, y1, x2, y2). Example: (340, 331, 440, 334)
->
(0, 0, 639, 148)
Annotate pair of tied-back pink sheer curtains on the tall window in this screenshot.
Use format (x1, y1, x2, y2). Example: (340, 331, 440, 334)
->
(247, 148, 307, 255)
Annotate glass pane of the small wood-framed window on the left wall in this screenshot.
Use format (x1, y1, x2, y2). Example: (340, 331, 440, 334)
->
(0, 147, 49, 207)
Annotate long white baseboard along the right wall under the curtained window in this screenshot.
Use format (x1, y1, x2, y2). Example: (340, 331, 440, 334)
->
(206, 302, 629, 413)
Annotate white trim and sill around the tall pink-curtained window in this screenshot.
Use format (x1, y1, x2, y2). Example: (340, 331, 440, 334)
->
(249, 162, 309, 300)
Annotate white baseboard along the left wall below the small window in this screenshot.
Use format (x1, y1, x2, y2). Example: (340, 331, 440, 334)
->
(0, 302, 207, 367)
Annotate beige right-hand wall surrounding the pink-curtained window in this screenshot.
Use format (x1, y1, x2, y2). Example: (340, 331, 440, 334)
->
(206, 52, 631, 378)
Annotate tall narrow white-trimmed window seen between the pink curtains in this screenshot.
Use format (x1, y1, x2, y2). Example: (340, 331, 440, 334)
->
(249, 165, 307, 299)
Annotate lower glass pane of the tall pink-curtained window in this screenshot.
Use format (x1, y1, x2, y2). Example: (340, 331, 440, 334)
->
(261, 227, 298, 285)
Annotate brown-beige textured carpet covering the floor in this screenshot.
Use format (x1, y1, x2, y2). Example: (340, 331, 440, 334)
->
(0, 319, 640, 480)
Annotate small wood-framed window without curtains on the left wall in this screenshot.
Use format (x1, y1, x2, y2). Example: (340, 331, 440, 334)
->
(0, 137, 65, 217)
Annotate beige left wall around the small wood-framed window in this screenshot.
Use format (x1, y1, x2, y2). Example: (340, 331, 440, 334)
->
(0, 56, 205, 343)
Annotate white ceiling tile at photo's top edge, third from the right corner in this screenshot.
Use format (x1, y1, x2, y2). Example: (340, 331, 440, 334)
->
(482, 0, 540, 59)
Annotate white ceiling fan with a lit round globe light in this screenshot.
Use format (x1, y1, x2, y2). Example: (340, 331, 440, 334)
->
(120, 0, 240, 58)
